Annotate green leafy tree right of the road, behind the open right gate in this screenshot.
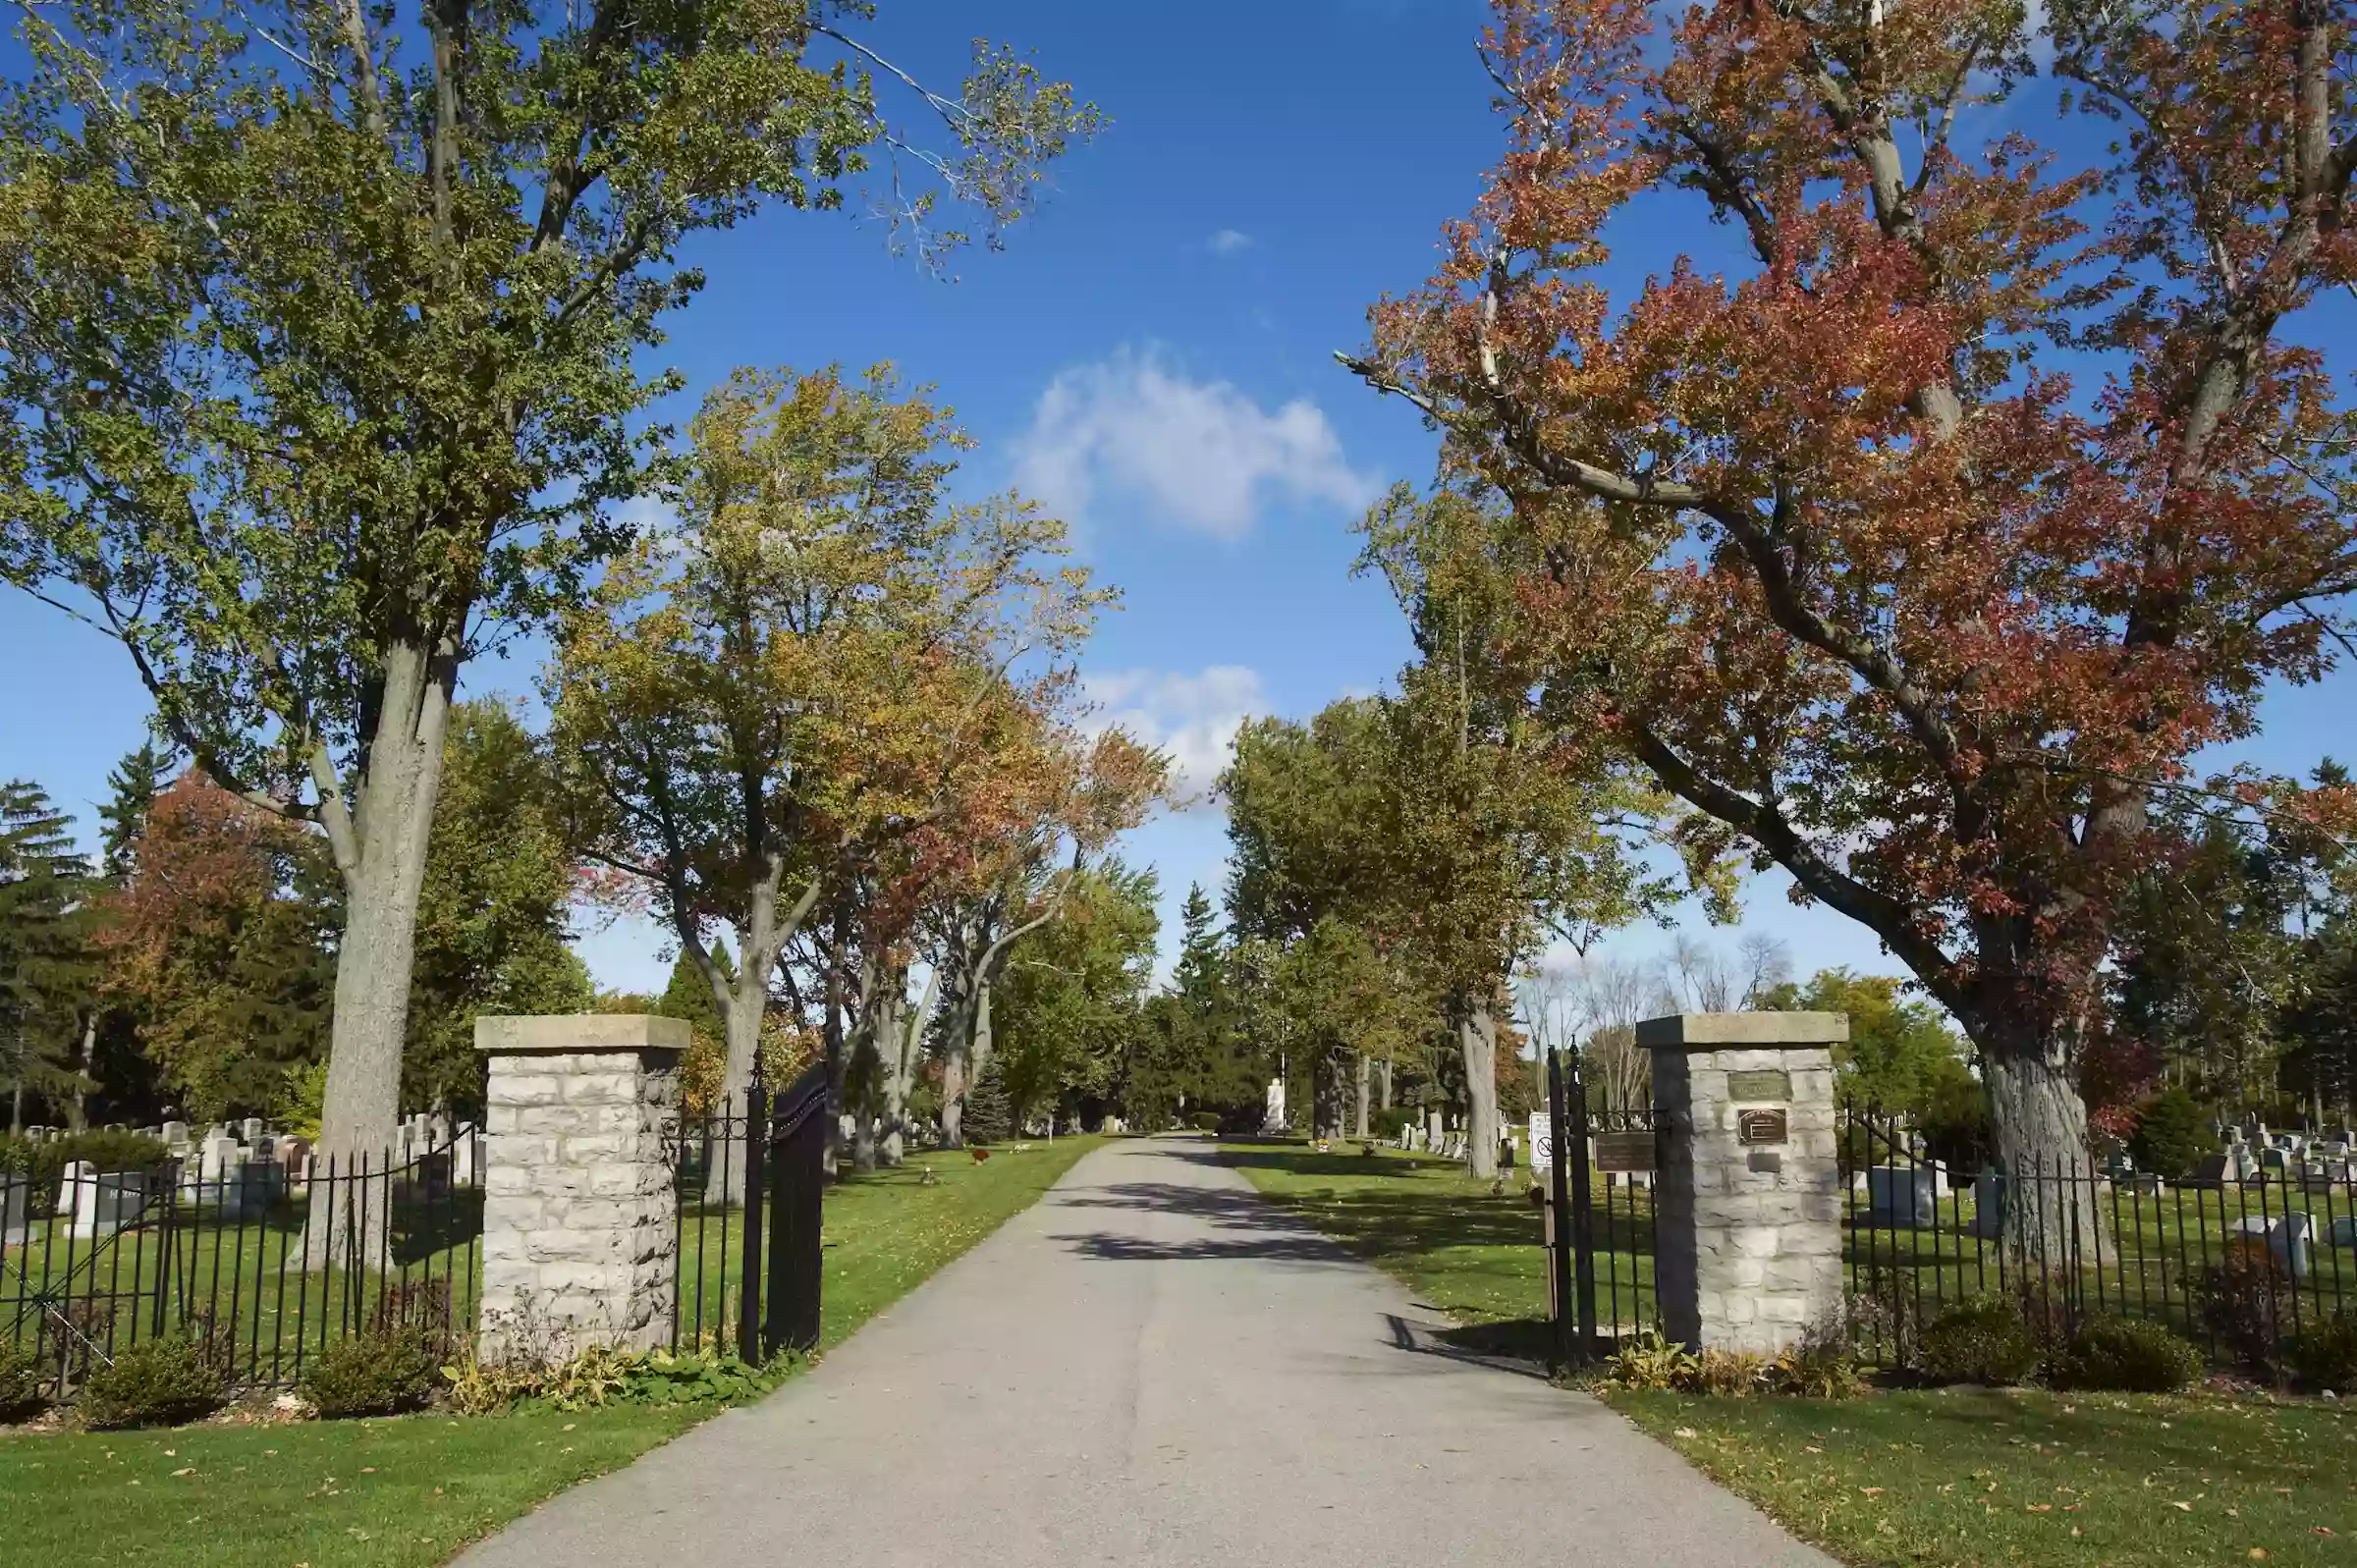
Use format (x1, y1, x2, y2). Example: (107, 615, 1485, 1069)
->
(1224, 650, 1660, 1176)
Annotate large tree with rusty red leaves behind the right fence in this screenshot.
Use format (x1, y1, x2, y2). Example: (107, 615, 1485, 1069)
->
(1345, 0, 2357, 1255)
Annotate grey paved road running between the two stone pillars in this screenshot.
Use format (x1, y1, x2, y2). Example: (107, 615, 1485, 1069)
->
(460, 1139, 1832, 1568)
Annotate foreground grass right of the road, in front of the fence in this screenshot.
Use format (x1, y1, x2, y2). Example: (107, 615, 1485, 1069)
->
(1610, 1388, 2357, 1568)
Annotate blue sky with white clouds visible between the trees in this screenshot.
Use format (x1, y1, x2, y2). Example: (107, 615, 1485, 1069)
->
(0, 0, 2350, 1004)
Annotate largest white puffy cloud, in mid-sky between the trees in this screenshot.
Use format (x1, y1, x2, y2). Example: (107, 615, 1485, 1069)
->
(1015, 349, 1377, 540)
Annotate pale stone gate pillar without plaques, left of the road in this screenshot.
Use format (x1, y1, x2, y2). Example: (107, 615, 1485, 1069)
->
(473, 1014, 690, 1361)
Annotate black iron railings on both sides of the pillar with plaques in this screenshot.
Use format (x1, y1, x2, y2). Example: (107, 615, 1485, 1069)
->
(1546, 1084, 2357, 1365)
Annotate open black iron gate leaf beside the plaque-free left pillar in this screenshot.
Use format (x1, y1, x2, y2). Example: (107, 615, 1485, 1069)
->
(738, 1063, 832, 1361)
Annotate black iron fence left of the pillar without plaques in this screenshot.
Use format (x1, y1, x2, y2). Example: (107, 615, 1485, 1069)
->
(0, 1149, 483, 1398)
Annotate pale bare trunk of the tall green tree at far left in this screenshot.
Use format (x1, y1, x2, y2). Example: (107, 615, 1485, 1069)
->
(304, 644, 458, 1269)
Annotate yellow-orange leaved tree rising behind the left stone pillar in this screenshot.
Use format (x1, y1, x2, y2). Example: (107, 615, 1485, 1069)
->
(549, 365, 1110, 1178)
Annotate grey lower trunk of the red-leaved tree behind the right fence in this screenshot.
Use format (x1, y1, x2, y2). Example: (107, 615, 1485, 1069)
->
(1975, 1030, 2105, 1275)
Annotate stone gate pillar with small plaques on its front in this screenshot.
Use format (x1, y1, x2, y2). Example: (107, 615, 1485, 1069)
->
(1636, 1011, 1850, 1356)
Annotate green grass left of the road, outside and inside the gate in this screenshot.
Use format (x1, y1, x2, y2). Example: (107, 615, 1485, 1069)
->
(0, 1139, 1101, 1568)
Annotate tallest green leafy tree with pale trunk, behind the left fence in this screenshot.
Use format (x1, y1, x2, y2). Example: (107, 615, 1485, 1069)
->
(0, 0, 1096, 1173)
